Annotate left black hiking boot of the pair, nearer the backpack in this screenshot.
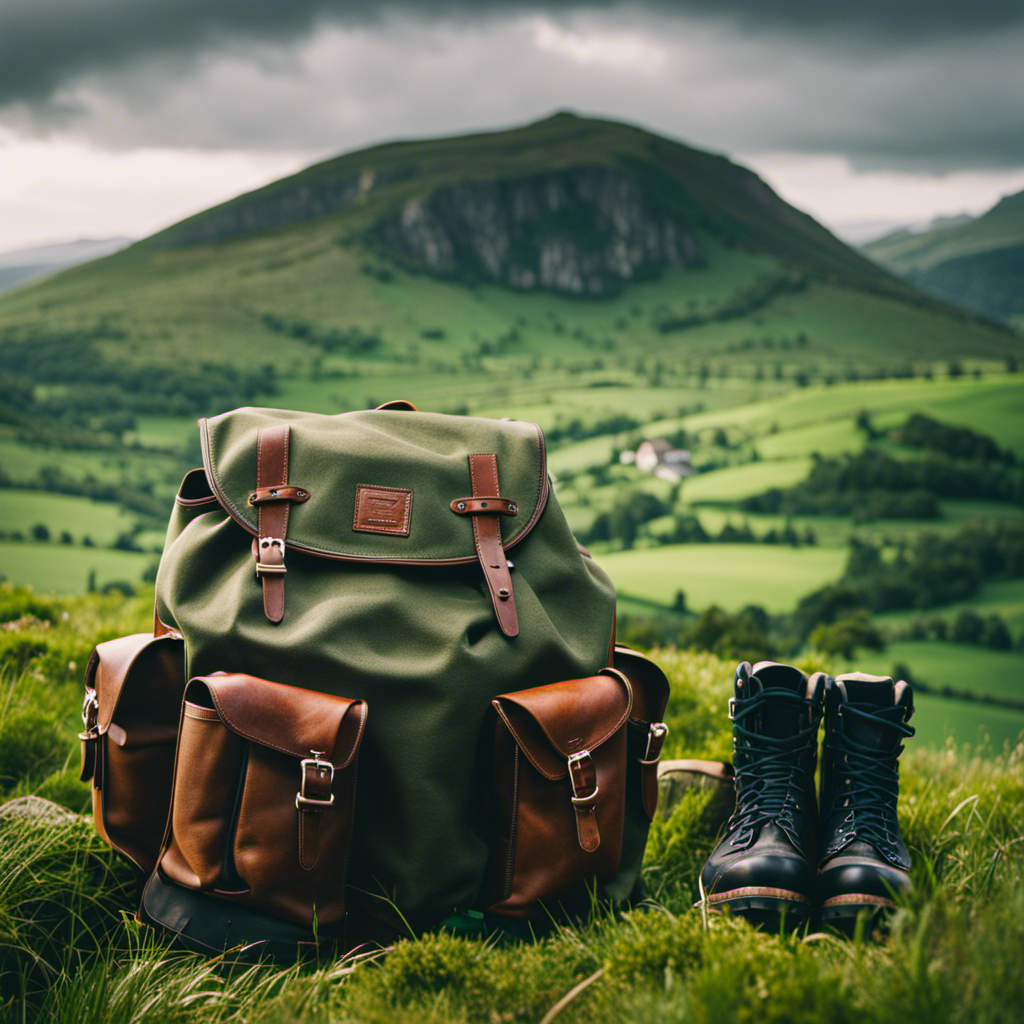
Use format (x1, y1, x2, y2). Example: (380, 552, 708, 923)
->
(699, 662, 826, 929)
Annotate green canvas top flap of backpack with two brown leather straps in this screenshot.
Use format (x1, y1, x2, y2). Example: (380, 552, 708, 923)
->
(200, 409, 549, 637)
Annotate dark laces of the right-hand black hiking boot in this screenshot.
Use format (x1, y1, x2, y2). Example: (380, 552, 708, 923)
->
(829, 705, 914, 852)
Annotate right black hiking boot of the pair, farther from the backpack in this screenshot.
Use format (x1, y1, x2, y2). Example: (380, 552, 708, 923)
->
(817, 672, 913, 930)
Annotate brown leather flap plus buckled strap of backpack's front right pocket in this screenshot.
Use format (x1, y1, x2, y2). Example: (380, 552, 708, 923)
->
(493, 669, 633, 853)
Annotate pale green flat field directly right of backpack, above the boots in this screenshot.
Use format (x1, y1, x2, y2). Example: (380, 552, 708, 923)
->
(598, 544, 846, 612)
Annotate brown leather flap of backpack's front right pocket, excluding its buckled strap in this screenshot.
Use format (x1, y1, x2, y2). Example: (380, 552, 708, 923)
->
(492, 669, 633, 779)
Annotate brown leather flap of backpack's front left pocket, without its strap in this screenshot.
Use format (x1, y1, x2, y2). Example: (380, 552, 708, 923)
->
(185, 673, 367, 768)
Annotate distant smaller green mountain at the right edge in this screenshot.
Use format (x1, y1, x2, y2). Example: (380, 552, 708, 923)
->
(863, 191, 1024, 327)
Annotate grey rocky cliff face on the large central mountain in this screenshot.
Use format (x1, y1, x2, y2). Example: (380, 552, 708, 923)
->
(370, 166, 705, 296)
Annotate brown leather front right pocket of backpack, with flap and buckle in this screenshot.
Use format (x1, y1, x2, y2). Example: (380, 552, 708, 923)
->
(481, 669, 633, 918)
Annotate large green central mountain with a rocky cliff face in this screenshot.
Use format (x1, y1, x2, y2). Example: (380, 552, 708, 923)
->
(0, 114, 1014, 422)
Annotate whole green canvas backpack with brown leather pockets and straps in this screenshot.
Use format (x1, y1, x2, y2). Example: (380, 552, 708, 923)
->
(82, 402, 669, 956)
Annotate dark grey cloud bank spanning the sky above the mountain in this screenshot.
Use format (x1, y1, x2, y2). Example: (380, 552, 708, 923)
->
(0, 0, 1024, 172)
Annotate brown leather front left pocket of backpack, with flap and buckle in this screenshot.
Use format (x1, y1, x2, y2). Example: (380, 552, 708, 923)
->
(160, 674, 367, 927)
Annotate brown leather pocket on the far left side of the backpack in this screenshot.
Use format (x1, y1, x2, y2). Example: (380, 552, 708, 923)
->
(79, 634, 184, 874)
